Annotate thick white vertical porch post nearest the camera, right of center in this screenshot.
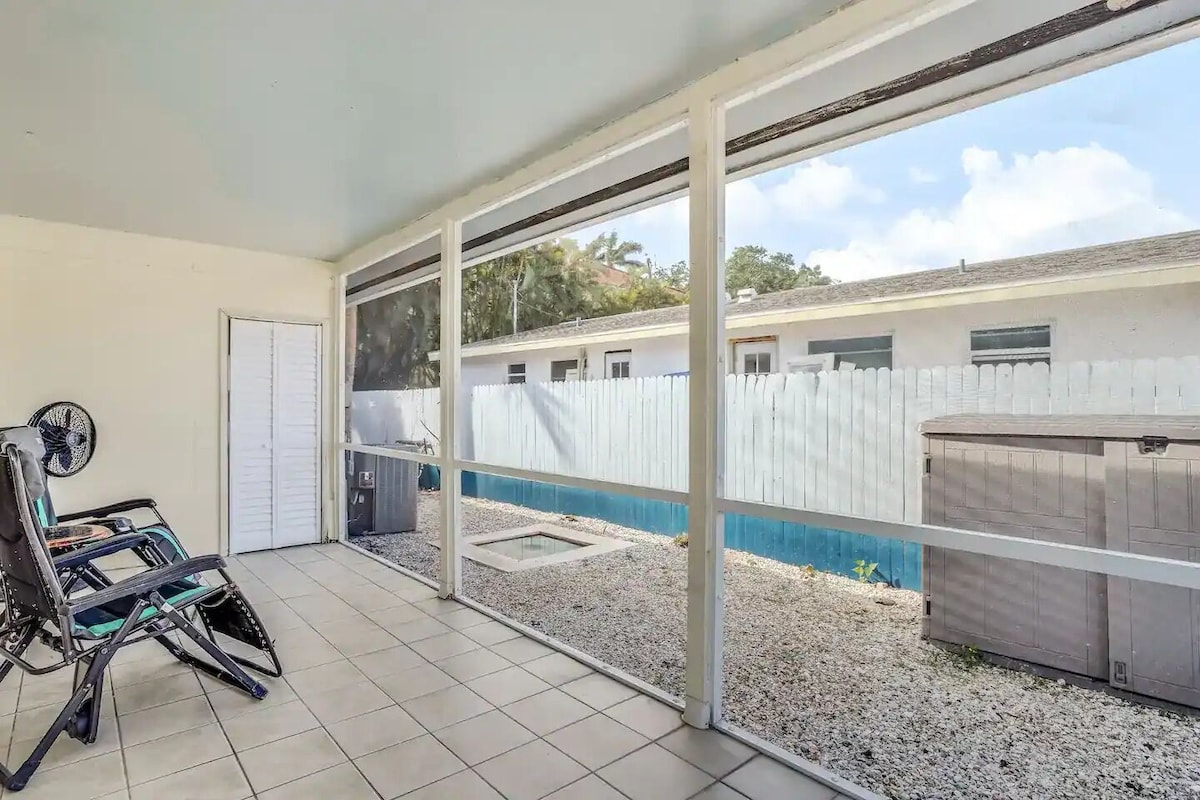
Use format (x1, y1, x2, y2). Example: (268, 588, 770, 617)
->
(683, 100, 726, 728)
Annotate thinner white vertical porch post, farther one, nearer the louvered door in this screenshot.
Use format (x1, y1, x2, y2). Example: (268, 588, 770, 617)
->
(438, 219, 462, 597)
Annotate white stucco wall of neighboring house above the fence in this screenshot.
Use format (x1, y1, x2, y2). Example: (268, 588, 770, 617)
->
(463, 284, 1200, 385)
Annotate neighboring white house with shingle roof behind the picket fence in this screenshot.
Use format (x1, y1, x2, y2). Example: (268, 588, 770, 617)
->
(448, 231, 1200, 386)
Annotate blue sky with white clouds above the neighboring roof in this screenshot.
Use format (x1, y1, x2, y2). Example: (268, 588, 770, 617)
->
(571, 40, 1200, 281)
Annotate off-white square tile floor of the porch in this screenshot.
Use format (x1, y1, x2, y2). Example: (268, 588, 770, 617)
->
(0, 545, 854, 800)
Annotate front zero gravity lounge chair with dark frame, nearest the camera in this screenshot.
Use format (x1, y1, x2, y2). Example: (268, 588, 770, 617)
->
(0, 429, 277, 792)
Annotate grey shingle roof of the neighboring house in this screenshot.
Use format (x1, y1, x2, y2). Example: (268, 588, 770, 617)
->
(463, 230, 1200, 353)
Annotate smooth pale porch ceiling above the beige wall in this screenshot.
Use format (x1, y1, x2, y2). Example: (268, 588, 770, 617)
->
(0, 0, 841, 259)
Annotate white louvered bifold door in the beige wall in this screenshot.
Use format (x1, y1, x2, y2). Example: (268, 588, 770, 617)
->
(229, 319, 320, 553)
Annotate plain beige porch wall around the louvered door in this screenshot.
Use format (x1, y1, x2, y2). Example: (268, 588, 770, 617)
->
(0, 216, 334, 561)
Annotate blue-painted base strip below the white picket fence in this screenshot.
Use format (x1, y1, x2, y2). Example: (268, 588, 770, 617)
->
(462, 473, 920, 590)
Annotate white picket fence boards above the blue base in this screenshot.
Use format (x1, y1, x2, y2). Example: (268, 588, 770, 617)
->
(354, 356, 1200, 521)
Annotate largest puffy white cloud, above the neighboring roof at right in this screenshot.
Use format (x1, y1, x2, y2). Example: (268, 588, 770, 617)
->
(804, 144, 1193, 281)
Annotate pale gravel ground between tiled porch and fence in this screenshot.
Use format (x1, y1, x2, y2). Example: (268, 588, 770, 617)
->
(356, 493, 1200, 800)
